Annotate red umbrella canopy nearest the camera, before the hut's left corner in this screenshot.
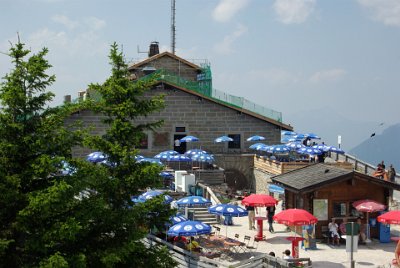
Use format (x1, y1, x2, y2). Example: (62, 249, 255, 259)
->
(273, 208, 318, 226)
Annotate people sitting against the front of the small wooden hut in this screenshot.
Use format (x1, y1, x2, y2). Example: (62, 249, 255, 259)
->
(328, 217, 367, 246)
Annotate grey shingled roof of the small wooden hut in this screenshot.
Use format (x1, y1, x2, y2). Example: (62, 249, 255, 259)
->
(271, 163, 400, 193)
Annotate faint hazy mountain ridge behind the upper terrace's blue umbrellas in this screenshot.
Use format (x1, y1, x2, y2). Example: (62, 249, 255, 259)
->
(283, 108, 383, 152)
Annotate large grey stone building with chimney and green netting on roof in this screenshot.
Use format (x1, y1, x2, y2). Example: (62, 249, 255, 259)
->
(67, 42, 292, 191)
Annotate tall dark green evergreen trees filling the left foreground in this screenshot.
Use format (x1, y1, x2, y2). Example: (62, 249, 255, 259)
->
(0, 39, 175, 267)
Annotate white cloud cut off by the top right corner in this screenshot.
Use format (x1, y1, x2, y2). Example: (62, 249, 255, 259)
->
(358, 0, 400, 26)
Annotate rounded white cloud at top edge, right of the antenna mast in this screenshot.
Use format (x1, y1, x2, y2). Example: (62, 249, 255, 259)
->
(274, 0, 316, 24)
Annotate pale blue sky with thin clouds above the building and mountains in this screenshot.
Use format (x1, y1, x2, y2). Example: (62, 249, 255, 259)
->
(0, 0, 400, 149)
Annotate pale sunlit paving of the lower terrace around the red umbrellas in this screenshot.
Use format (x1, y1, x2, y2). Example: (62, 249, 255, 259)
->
(212, 202, 399, 268)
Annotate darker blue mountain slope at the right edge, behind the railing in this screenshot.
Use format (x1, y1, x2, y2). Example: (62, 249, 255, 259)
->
(348, 123, 400, 170)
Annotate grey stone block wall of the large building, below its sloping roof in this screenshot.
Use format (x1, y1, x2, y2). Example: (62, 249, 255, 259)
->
(66, 88, 280, 157)
